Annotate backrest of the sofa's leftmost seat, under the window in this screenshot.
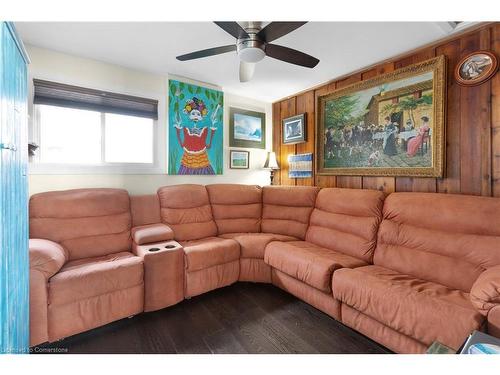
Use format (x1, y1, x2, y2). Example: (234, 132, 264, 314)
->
(29, 189, 132, 260)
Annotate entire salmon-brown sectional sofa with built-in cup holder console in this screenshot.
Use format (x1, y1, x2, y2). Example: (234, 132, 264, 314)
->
(30, 184, 500, 353)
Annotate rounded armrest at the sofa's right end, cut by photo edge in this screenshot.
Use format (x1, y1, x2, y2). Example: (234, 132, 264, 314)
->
(470, 265, 500, 316)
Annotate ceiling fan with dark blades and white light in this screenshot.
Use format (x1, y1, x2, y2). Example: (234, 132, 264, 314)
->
(177, 22, 319, 82)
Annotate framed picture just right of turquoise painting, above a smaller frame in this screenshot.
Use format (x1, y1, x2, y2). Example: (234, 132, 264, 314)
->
(229, 108, 266, 149)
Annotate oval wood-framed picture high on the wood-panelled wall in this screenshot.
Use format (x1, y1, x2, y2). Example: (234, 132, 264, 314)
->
(455, 51, 498, 86)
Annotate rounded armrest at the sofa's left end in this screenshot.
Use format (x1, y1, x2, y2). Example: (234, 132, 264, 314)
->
(29, 238, 67, 279)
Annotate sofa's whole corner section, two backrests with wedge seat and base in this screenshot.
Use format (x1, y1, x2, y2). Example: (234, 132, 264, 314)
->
(211, 184, 317, 283)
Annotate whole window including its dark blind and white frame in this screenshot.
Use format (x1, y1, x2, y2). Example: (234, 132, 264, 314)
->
(32, 80, 157, 173)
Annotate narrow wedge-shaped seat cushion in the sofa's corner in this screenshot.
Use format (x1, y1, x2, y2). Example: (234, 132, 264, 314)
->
(219, 233, 298, 259)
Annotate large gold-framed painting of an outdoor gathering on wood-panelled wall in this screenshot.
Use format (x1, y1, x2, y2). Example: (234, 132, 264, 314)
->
(316, 56, 446, 177)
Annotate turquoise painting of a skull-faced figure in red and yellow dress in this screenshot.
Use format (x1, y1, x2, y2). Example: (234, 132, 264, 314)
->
(168, 80, 224, 175)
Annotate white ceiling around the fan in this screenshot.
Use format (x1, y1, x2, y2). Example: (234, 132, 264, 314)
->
(16, 22, 460, 102)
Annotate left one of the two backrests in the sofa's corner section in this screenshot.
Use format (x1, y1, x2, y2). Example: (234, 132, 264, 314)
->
(206, 184, 262, 234)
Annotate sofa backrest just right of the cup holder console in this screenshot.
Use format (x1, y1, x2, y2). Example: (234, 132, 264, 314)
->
(158, 184, 217, 241)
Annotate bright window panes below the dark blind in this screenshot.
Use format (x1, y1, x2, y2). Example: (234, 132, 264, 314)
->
(36, 105, 154, 165)
